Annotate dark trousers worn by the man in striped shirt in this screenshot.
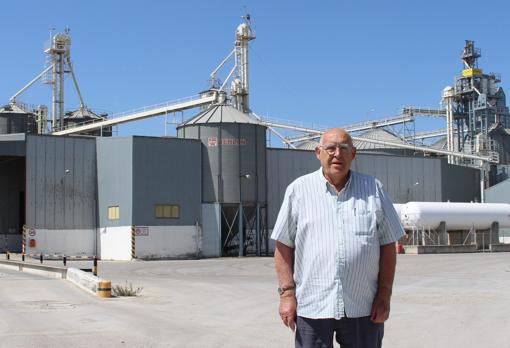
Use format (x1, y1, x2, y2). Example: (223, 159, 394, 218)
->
(296, 317, 384, 348)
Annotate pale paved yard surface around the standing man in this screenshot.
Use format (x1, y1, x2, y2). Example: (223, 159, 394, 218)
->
(0, 253, 510, 348)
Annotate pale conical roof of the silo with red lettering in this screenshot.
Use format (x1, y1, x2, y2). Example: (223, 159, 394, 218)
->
(179, 104, 261, 127)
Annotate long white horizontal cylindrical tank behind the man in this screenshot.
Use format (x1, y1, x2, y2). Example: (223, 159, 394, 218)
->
(401, 202, 510, 230)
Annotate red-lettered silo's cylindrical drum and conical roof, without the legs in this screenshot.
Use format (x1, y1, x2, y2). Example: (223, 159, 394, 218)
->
(177, 105, 266, 204)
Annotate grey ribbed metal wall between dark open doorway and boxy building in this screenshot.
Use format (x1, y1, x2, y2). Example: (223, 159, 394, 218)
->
(26, 135, 96, 229)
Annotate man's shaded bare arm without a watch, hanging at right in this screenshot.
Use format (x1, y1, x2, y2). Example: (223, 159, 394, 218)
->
(370, 243, 397, 323)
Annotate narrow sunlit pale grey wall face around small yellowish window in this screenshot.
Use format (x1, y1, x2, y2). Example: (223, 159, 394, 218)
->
(96, 137, 133, 227)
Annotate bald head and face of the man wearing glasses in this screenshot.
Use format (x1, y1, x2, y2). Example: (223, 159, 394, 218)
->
(315, 129, 356, 181)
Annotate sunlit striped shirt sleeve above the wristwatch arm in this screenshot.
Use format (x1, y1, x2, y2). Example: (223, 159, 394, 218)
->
(271, 184, 297, 248)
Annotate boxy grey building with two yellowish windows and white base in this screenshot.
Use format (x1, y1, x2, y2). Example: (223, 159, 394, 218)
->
(97, 136, 201, 259)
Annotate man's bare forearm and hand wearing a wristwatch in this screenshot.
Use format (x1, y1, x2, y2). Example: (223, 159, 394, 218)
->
(274, 241, 297, 330)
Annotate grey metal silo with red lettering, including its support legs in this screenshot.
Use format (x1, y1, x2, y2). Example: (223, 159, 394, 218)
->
(177, 105, 267, 255)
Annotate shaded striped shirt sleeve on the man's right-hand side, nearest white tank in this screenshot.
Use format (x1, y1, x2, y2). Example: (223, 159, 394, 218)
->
(376, 180, 405, 245)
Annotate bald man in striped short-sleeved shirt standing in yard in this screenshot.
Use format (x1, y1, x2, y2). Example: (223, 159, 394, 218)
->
(271, 128, 404, 348)
